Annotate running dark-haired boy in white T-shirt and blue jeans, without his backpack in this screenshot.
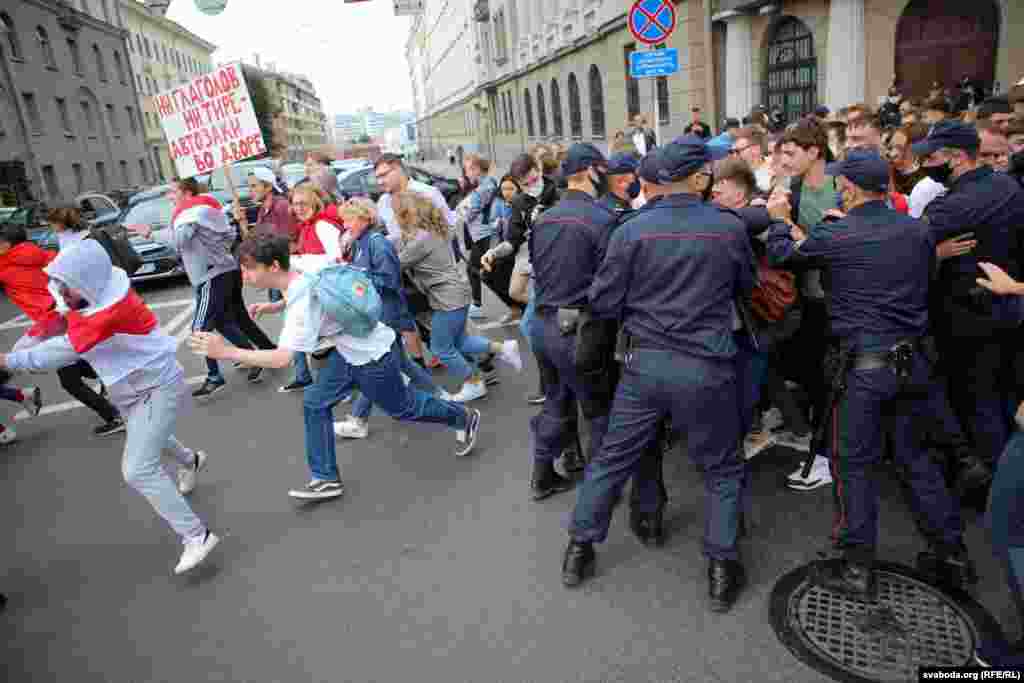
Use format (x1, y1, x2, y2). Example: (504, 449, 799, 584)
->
(188, 234, 480, 500)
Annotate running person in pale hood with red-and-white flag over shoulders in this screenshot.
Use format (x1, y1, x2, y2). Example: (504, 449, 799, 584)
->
(0, 240, 220, 573)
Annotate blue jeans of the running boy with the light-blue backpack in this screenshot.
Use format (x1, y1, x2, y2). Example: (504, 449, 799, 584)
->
(302, 343, 466, 480)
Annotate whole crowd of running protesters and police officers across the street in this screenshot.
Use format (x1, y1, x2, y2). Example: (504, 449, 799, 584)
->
(6, 81, 1024, 663)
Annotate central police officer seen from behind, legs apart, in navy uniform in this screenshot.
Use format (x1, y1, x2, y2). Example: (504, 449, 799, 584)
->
(562, 136, 755, 611)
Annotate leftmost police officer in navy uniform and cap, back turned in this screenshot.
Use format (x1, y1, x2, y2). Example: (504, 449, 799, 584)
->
(528, 143, 616, 501)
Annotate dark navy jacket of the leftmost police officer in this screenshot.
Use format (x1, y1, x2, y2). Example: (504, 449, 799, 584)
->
(529, 189, 617, 308)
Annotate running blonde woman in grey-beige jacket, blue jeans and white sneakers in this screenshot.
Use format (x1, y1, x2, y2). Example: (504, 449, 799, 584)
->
(391, 191, 522, 402)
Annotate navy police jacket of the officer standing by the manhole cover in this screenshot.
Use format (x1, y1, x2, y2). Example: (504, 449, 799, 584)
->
(768, 201, 935, 351)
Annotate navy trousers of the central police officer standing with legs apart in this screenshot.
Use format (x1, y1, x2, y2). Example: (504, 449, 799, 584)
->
(569, 348, 745, 559)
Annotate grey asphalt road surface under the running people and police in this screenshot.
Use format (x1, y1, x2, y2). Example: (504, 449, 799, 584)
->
(0, 274, 1017, 683)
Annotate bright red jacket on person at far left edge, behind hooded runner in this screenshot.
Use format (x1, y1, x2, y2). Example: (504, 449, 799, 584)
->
(0, 242, 62, 337)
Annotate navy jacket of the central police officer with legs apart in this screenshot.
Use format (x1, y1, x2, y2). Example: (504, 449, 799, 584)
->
(590, 195, 755, 359)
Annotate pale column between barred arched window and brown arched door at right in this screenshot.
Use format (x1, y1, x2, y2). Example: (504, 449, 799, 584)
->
(824, 0, 867, 111)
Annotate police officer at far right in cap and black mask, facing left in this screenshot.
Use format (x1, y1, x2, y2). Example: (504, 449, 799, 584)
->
(911, 121, 1024, 475)
